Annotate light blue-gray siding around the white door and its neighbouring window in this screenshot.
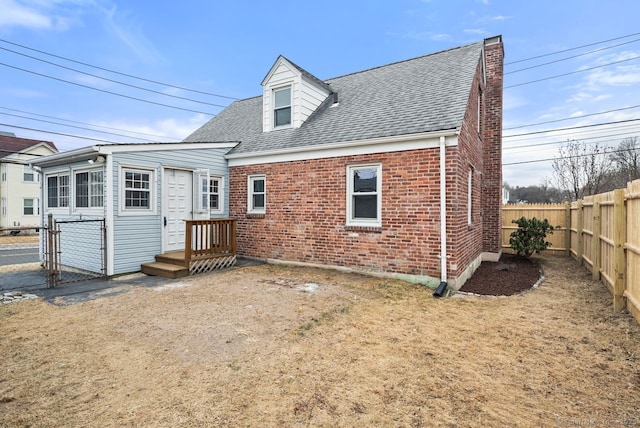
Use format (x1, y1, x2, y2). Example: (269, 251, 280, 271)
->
(110, 148, 229, 274)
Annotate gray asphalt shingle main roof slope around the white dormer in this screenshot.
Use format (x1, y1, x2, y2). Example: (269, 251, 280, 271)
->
(184, 42, 483, 153)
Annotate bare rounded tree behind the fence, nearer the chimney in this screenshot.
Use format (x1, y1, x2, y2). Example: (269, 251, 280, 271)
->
(552, 140, 613, 200)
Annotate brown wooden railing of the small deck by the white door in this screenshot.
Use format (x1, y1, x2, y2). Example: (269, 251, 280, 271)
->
(184, 218, 236, 267)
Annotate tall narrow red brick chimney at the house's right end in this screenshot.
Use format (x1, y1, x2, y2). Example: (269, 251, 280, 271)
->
(482, 36, 504, 260)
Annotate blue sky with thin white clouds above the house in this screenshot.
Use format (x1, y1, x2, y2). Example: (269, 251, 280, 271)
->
(0, 0, 640, 186)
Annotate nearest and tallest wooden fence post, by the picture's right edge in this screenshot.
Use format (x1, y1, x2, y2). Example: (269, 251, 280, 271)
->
(613, 189, 627, 311)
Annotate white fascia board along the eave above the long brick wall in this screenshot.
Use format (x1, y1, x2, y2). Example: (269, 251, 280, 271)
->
(225, 129, 458, 167)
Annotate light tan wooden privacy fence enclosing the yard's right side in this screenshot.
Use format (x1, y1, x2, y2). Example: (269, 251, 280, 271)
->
(502, 180, 640, 322)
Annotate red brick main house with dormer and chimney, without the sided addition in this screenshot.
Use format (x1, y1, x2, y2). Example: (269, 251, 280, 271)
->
(185, 36, 504, 288)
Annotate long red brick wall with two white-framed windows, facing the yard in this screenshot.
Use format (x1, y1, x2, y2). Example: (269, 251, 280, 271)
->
(230, 148, 456, 278)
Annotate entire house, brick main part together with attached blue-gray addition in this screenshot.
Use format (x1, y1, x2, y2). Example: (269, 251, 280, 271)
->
(33, 36, 504, 288)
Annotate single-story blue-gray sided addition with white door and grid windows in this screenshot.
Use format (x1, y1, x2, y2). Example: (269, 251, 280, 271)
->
(33, 143, 235, 276)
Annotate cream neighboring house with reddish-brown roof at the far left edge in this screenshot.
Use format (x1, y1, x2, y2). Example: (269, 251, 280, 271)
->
(0, 132, 58, 233)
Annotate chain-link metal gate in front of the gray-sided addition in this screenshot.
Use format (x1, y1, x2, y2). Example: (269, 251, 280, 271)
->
(42, 215, 107, 287)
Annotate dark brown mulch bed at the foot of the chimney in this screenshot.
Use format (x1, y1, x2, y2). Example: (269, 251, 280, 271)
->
(460, 254, 542, 296)
